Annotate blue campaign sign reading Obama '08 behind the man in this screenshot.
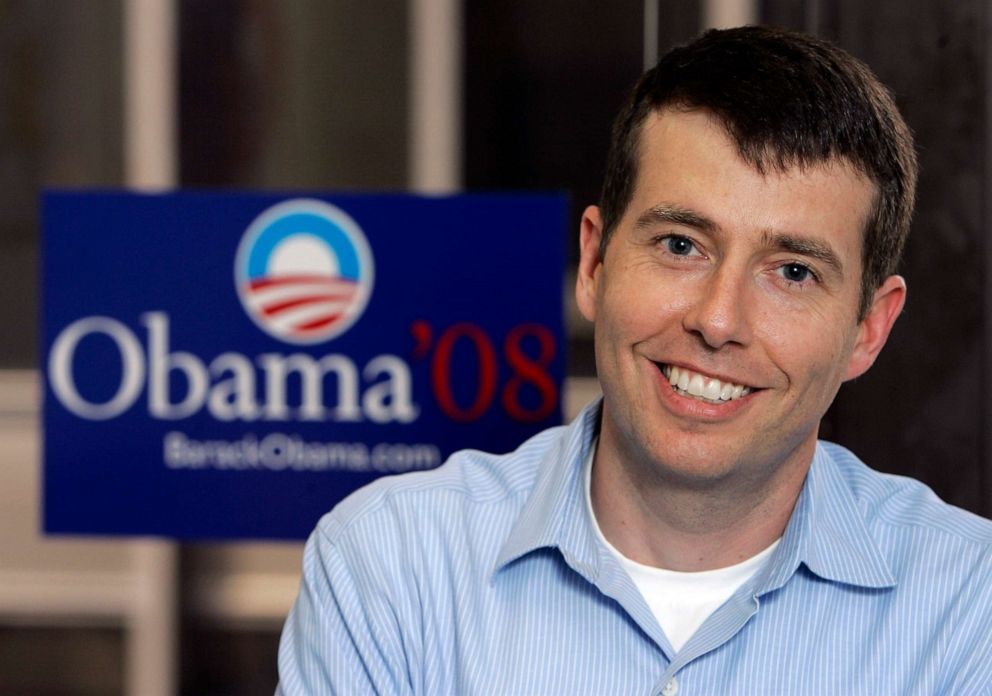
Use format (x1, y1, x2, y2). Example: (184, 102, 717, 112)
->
(42, 192, 567, 539)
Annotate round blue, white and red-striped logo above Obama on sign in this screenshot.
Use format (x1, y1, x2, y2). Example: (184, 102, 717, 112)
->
(234, 198, 375, 345)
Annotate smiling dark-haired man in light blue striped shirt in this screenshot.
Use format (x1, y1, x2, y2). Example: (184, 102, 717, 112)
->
(280, 27, 992, 696)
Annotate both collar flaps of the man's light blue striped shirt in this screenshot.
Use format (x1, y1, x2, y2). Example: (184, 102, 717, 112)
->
(493, 399, 896, 594)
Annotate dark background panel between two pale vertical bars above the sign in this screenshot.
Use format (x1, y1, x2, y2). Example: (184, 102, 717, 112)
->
(179, 0, 407, 189)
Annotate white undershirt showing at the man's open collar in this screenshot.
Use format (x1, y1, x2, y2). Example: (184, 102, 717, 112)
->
(585, 448, 779, 652)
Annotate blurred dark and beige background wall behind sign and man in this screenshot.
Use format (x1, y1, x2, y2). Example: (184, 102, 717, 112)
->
(0, 0, 992, 696)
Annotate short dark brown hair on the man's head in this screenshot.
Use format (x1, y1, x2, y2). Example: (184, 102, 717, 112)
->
(600, 27, 917, 318)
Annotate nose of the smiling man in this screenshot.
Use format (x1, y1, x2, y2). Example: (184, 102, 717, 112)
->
(682, 266, 752, 348)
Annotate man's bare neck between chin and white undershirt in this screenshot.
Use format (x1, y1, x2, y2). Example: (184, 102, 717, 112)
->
(590, 424, 812, 572)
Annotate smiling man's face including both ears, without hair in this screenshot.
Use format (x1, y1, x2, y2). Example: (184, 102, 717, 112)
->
(577, 110, 905, 485)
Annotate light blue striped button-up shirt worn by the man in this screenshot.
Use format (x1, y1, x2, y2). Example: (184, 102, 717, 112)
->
(277, 404, 992, 696)
